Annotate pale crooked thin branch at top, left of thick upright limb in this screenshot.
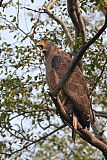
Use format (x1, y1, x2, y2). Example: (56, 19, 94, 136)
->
(44, 0, 73, 43)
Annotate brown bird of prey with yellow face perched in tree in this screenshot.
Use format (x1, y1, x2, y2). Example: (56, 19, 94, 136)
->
(37, 39, 90, 141)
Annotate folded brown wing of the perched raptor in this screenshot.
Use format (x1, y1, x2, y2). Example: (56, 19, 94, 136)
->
(51, 52, 90, 127)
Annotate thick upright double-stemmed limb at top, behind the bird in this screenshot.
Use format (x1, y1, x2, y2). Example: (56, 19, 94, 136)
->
(67, 0, 87, 72)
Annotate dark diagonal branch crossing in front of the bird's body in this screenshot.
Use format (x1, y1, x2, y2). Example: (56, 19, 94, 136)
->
(51, 14, 107, 96)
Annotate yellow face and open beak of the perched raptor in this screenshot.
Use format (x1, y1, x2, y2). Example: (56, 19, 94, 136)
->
(37, 39, 49, 52)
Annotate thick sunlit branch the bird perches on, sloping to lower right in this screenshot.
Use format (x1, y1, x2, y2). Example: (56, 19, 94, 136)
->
(50, 95, 107, 158)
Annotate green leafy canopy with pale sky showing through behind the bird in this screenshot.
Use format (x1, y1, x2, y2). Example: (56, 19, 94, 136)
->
(0, 0, 107, 160)
